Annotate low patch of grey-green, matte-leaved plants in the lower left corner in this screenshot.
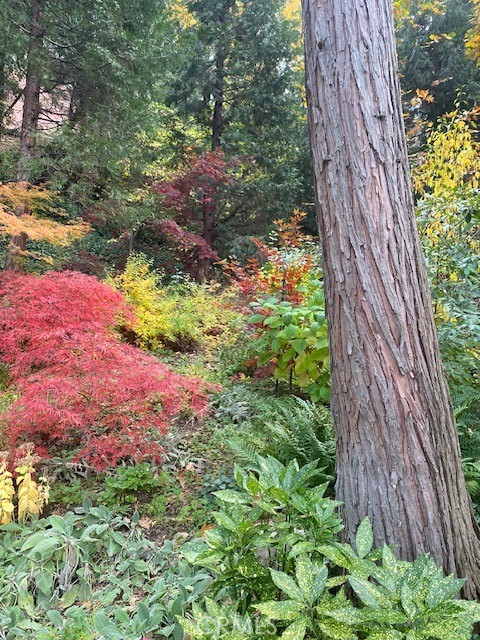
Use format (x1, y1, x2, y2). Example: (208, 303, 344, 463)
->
(0, 499, 211, 640)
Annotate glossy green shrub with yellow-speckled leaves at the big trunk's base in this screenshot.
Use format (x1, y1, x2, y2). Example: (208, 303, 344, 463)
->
(181, 458, 480, 640)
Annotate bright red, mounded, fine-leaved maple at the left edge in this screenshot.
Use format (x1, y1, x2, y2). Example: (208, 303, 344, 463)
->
(0, 272, 210, 469)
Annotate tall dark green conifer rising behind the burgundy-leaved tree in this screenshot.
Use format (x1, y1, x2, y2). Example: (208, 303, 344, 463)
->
(167, 0, 309, 237)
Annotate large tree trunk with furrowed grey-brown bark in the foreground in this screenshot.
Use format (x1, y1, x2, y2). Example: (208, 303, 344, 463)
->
(303, 0, 480, 598)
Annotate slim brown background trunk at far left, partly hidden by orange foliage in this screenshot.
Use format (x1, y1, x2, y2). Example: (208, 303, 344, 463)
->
(5, 0, 44, 271)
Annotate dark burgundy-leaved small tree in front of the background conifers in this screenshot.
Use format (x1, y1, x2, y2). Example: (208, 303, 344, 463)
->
(153, 150, 236, 279)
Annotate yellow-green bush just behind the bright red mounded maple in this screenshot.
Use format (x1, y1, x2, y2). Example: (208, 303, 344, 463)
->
(110, 255, 242, 353)
